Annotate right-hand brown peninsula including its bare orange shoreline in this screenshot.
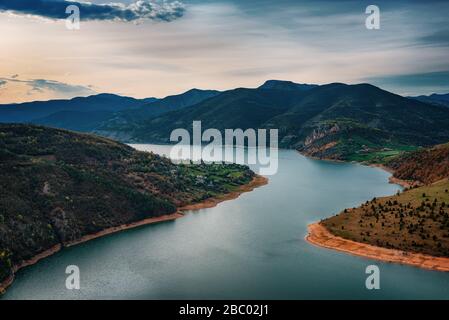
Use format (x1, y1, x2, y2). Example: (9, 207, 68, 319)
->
(306, 144, 449, 271)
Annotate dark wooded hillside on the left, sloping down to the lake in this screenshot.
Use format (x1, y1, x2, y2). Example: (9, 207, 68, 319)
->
(0, 125, 254, 283)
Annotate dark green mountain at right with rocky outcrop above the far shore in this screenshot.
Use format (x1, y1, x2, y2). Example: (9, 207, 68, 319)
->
(290, 84, 449, 162)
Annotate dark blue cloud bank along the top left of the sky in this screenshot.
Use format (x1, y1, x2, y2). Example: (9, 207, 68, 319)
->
(0, 0, 185, 21)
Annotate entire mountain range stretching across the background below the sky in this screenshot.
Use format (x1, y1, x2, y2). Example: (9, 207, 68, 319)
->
(0, 80, 449, 162)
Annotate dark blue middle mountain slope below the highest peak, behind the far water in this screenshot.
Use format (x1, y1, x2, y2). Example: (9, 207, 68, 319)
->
(102, 88, 304, 143)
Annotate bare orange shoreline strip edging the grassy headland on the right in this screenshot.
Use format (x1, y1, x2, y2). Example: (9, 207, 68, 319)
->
(306, 223, 449, 272)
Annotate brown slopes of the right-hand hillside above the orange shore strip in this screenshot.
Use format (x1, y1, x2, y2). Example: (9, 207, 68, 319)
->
(320, 144, 449, 267)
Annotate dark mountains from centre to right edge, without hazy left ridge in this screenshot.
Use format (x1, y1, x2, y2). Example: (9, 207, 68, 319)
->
(100, 83, 449, 162)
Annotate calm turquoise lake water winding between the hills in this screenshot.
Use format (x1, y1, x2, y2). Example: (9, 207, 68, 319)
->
(4, 145, 449, 299)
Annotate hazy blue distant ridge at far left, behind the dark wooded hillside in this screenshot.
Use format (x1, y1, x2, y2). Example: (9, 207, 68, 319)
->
(0, 89, 219, 135)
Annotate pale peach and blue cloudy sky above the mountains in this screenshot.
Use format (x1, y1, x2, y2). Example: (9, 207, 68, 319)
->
(0, 0, 449, 103)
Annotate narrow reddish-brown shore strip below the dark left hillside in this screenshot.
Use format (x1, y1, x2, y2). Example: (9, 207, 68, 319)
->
(0, 175, 268, 294)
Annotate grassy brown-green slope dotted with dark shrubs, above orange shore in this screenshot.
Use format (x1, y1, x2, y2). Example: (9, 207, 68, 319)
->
(322, 179, 449, 257)
